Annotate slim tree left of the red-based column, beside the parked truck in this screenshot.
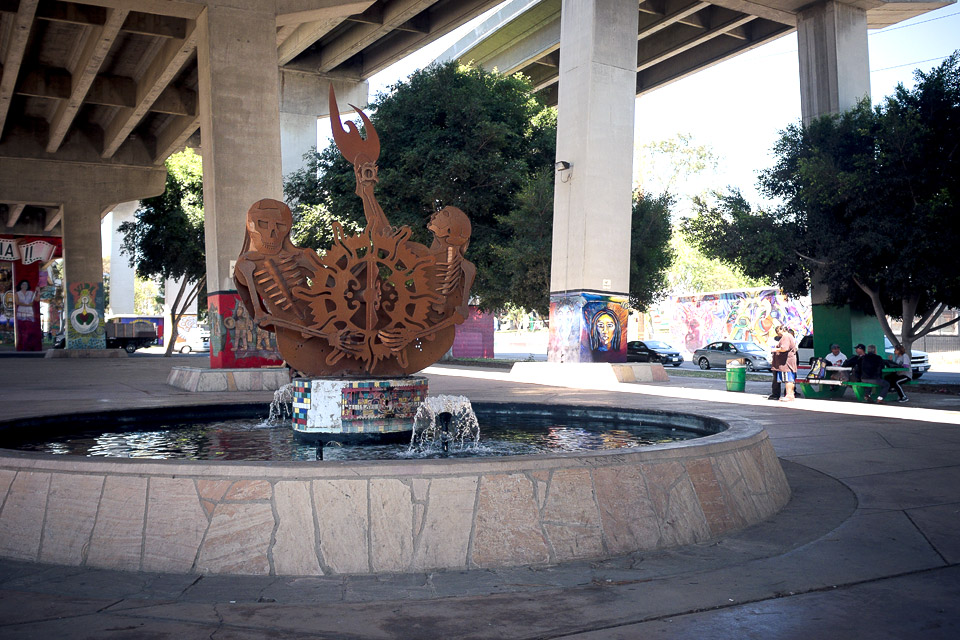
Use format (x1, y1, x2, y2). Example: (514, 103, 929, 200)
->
(120, 149, 206, 356)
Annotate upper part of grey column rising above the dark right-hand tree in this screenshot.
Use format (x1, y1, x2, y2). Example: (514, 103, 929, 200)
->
(797, 0, 870, 123)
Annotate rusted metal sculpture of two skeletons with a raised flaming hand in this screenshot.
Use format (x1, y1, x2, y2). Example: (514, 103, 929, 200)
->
(234, 87, 476, 377)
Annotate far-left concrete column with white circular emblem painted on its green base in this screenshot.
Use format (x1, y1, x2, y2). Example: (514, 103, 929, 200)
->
(63, 200, 107, 349)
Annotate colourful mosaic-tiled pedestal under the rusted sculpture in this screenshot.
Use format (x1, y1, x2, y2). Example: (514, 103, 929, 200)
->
(293, 376, 427, 440)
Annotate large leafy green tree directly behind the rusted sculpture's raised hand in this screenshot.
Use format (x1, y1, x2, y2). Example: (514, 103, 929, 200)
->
(284, 62, 556, 308)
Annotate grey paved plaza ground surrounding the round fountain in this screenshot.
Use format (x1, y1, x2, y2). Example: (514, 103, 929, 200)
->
(0, 354, 960, 640)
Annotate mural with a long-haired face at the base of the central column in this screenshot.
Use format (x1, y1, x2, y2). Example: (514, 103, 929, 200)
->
(548, 293, 627, 362)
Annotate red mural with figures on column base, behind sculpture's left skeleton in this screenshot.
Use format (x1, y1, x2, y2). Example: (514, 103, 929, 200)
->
(207, 292, 283, 369)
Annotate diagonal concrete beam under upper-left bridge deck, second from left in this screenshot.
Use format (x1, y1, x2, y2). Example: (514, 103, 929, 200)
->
(47, 9, 130, 153)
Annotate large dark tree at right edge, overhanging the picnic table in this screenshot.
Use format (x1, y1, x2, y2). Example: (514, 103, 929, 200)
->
(685, 51, 960, 353)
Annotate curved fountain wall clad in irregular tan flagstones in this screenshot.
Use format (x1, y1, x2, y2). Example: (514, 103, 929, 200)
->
(0, 421, 790, 575)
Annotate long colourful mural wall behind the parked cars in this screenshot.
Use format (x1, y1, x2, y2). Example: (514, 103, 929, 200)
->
(644, 288, 813, 357)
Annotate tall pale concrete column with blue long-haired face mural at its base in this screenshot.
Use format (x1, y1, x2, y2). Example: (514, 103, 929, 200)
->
(548, 0, 638, 362)
